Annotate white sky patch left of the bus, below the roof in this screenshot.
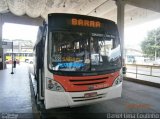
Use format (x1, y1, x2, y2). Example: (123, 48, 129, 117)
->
(2, 23, 38, 42)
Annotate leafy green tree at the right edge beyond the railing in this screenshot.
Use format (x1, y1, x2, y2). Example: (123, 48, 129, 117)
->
(141, 28, 160, 57)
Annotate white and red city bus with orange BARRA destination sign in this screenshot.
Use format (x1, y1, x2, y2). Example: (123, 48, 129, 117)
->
(33, 13, 123, 109)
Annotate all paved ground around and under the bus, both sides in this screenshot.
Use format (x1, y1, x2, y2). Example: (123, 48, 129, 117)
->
(0, 63, 160, 119)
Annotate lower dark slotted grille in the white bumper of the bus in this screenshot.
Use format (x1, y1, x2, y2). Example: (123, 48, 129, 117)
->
(72, 93, 107, 102)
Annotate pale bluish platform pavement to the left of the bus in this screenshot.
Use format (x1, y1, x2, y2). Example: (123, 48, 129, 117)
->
(0, 63, 33, 118)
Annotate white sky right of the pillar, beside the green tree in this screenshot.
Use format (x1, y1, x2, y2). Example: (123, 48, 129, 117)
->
(124, 19, 160, 50)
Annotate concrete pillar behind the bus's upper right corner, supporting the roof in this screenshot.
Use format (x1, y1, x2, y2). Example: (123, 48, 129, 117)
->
(116, 0, 125, 58)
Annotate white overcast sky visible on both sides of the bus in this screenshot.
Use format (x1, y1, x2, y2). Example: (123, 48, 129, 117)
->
(3, 19, 160, 50)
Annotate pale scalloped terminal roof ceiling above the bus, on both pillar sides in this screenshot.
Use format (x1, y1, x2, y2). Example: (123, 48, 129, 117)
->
(0, 0, 160, 24)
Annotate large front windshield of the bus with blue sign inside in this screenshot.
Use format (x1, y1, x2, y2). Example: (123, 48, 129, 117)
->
(48, 31, 121, 72)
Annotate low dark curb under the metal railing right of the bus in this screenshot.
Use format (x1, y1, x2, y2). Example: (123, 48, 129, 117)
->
(123, 77, 160, 88)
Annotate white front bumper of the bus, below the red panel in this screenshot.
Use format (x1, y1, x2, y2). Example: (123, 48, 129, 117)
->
(45, 83, 122, 109)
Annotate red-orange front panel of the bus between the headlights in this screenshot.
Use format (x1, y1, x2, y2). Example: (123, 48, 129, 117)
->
(53, 71, 119, 92)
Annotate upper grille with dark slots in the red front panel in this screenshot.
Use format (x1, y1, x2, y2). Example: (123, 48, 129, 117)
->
(69, 77, 109, 86)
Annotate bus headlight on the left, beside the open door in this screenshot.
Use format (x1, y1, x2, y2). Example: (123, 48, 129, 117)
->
(46, 78, 65, 92)
